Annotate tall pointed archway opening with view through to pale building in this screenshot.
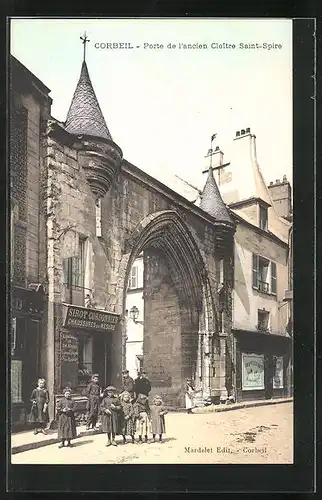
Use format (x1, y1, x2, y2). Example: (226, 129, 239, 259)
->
(123, 211, 211, 406)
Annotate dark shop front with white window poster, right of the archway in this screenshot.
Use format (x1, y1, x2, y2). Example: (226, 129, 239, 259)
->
(234, 330, 291, 401)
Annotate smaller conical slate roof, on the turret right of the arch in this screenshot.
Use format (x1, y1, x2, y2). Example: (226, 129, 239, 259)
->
(200, 168, 232, 222)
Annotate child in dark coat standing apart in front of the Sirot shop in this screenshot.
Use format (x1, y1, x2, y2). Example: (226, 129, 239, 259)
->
(57, 387, 77, 448)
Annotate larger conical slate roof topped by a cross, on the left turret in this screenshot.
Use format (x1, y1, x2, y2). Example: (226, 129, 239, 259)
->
(65, 61, 112, 139)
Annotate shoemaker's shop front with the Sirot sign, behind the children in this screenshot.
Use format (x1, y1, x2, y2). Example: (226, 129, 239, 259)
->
(56, 304, 119, 420)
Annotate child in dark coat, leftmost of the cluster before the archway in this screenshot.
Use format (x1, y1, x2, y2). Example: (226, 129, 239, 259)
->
(101, 385, 122, 446)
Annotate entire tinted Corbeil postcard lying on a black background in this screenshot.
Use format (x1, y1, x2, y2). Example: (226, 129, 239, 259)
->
(9, 18, 293, 465)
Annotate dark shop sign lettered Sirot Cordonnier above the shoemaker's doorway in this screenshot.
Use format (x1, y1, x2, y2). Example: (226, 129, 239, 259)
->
(64, 304, 119, 331)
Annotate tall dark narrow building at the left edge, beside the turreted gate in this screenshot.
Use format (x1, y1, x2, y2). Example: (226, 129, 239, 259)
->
(9, 57, 51, 427)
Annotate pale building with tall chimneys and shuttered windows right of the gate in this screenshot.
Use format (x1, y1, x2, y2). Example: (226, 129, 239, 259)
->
(209, 129, 292, 400)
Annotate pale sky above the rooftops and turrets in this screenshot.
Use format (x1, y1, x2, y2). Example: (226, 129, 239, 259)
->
(10, 18, 292, 193)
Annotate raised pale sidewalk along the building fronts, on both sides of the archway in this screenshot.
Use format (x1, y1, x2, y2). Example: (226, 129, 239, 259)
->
(11, 398, 293, 454)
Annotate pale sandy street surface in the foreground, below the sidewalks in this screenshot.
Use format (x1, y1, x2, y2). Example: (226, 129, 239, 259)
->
(11, 402, 293, 464)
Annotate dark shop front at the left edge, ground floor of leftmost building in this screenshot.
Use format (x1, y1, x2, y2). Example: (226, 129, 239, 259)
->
(10, 286, 45, 429)
